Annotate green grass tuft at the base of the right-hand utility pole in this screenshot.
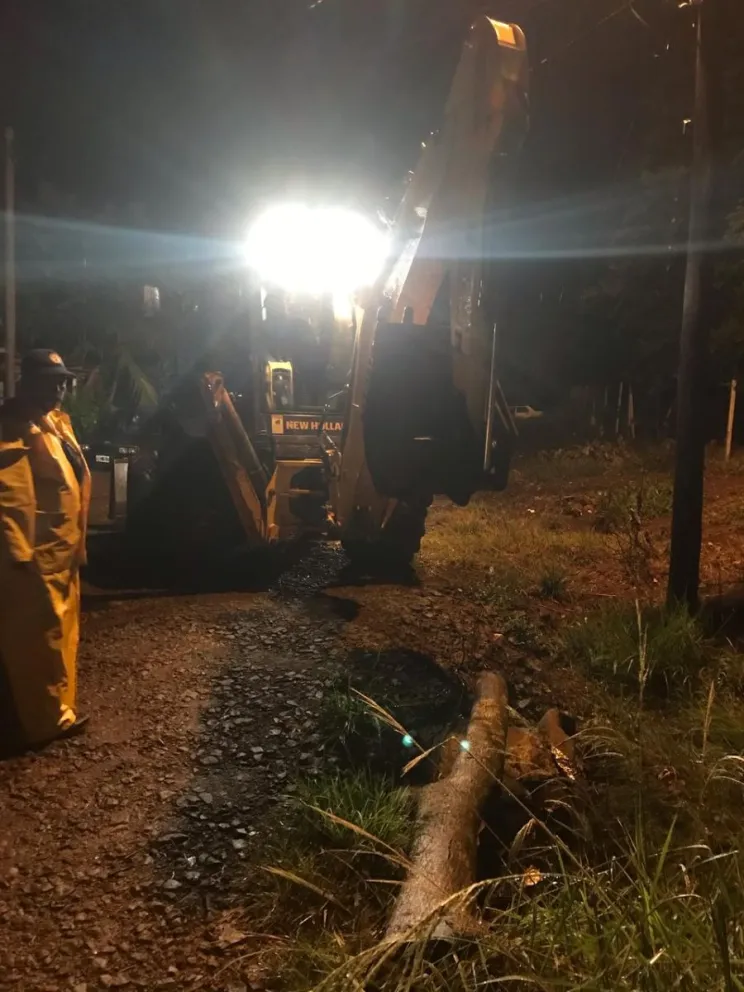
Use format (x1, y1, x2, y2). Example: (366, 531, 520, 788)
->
(565, 605, 713, 694)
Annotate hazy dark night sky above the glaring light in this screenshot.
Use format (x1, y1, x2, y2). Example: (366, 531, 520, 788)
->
(0, 0, 679, 233)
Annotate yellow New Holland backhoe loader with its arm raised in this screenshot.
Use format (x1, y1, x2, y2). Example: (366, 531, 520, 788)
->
(127, 17, 528, 567)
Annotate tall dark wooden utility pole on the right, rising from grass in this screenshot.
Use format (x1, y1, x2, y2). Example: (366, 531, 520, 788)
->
(667, 0, 717, 610)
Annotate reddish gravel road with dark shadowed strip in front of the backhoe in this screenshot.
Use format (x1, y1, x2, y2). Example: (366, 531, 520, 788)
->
(0, 560, 348, 992)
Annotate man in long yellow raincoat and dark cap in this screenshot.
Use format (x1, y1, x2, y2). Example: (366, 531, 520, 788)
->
(0, 348, 90, 747)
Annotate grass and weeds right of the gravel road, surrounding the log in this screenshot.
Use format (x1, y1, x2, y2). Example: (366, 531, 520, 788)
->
(244, 453, 744, 992)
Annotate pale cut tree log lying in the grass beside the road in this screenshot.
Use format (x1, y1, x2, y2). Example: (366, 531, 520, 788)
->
(387, 672, 508, 938)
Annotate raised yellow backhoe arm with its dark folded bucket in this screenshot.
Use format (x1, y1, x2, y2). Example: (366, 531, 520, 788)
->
(332, 17, 528, 543)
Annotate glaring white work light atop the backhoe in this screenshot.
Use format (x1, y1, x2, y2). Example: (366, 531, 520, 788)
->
(246, 204, 388, 296)
